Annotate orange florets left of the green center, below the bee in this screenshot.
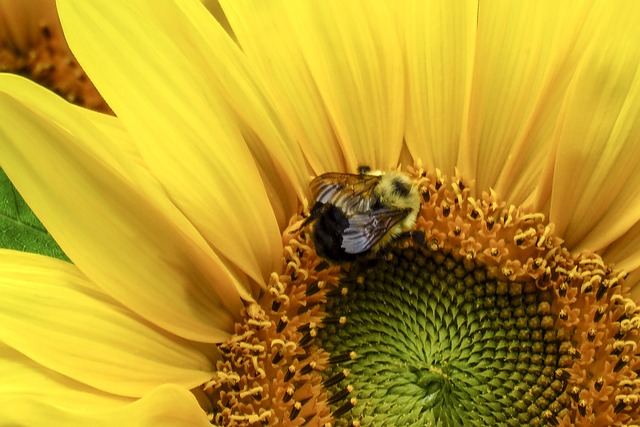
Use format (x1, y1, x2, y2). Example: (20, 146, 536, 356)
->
(203, 226, 338, 427)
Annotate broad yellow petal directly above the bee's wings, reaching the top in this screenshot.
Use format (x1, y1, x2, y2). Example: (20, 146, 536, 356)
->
(228, 1, 404, 173)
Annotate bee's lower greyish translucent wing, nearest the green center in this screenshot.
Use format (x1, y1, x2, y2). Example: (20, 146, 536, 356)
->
(342, 208, 410, 254)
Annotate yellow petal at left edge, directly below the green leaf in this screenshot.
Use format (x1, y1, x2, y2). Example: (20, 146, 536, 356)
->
(0, 254, 215, 397)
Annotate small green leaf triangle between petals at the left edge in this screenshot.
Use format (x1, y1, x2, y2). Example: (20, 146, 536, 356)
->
(0, 169, 69, 261)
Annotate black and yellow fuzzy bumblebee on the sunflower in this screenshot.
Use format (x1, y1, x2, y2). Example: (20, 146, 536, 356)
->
(302, 167, 421, 262)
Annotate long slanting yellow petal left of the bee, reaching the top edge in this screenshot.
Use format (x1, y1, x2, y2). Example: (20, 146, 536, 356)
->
(59, 1, 304, 283)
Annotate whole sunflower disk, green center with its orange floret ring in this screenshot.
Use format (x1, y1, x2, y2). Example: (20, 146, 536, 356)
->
(203, 167, 640, 427)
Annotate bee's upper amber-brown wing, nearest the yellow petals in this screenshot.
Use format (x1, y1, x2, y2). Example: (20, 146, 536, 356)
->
(309, 172, 380, 213)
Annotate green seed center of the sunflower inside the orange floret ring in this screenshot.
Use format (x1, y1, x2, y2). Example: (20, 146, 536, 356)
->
(318, 247, 566, 426)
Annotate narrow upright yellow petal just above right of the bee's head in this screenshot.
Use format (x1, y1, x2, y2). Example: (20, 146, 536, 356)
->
(397, 0, 484, 175)
